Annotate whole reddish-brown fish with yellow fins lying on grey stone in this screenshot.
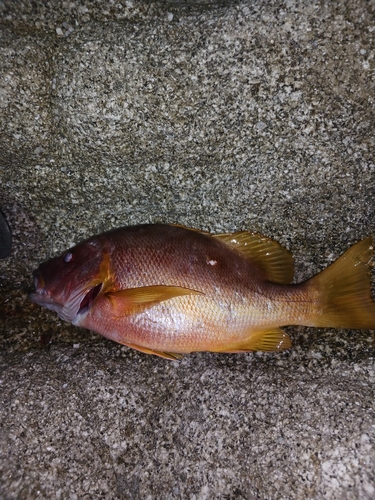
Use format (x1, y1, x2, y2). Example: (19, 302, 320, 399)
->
(29, 224, 375, 359)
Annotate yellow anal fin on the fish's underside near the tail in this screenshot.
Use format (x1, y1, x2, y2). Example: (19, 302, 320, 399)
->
(216, 328, 292, 353)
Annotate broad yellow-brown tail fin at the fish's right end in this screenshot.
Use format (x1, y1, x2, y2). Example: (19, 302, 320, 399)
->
(306, 237, 375, 329)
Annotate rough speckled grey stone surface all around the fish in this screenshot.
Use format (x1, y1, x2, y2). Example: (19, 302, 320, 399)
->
(0, 0, 375, 499)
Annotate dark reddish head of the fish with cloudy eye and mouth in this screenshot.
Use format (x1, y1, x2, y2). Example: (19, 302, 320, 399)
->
(29, 239, 111, 323)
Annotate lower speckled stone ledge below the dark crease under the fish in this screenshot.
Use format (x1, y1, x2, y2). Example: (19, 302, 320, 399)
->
(0, 342, 375, 499)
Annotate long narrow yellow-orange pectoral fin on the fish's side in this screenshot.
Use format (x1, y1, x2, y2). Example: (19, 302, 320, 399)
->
(106, 285, 202, 316)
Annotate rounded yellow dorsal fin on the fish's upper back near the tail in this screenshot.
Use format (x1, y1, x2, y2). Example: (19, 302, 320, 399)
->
(213, 231, 294, 285)
